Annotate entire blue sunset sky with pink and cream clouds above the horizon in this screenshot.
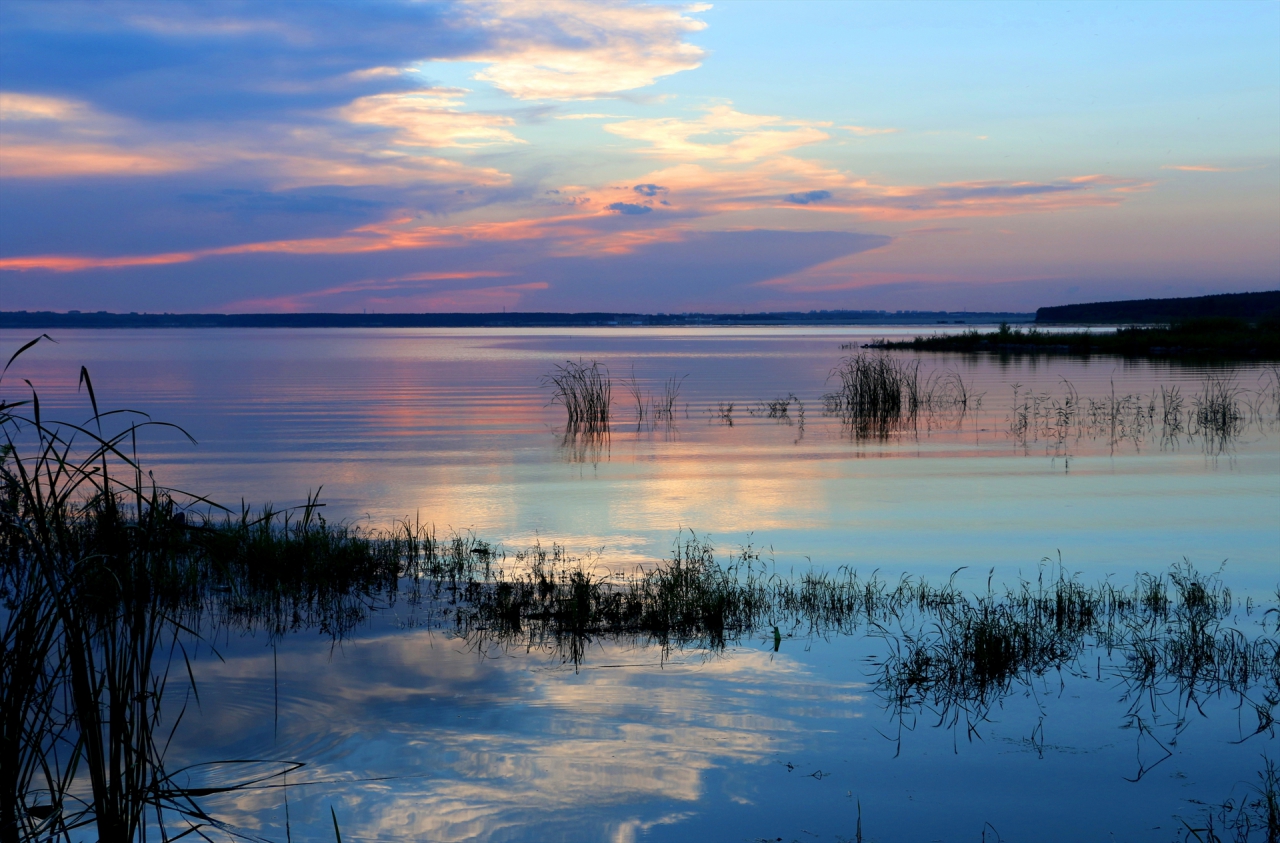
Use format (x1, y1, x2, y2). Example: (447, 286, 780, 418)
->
(0, 0, 1280, 312)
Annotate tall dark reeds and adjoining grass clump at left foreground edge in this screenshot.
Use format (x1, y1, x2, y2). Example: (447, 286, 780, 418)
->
(0, 343, 399, 843)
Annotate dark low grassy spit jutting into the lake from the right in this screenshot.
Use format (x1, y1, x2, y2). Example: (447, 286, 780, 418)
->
(863, 316, 1280, 361)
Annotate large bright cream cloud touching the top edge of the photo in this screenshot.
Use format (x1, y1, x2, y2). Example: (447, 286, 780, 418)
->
(455, 0, 710, 100)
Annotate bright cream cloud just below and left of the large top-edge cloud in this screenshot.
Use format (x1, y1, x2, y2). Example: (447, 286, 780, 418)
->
(338, 88, 524, 148)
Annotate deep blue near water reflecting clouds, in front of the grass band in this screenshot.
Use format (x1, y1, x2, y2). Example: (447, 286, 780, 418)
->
(174, 617, 1274, 842)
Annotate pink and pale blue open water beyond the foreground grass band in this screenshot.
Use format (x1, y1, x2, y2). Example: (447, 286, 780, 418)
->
(0, 326, 1280, 592)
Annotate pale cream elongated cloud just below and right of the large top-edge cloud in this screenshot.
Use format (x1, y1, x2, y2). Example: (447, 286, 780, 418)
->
(604, 105, 831, 161)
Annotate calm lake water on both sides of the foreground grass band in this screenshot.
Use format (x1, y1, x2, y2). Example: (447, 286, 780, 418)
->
(0, 327, 1280, 840)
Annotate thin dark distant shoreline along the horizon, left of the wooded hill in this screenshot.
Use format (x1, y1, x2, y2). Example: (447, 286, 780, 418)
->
(0, 311, 1036, 330)
